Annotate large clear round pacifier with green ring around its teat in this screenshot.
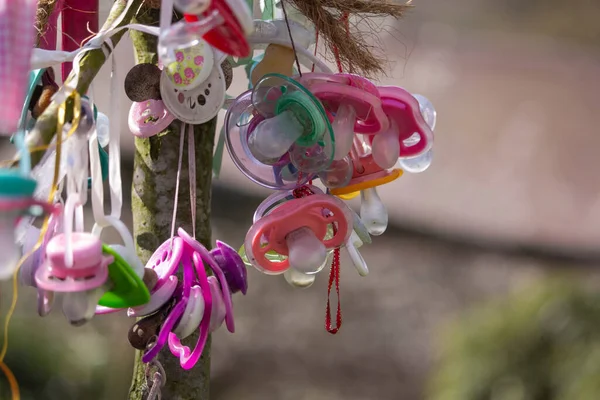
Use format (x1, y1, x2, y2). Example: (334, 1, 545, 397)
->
(225, 74, 335, 189)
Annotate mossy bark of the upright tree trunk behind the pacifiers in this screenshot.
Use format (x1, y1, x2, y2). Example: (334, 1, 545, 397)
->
(129, 6, 216, 400)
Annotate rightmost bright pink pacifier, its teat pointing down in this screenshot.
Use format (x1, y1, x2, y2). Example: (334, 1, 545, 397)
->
(369, 86, 433, 168)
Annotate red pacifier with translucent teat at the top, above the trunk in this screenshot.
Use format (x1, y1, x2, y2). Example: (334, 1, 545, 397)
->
(180, 0, 254, 57)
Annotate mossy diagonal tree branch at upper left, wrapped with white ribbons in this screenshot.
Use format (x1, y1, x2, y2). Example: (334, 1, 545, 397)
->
(26, 0, 143, 167)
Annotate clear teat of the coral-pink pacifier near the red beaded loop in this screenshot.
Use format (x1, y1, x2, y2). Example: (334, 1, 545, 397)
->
(285, 227, 327, 274)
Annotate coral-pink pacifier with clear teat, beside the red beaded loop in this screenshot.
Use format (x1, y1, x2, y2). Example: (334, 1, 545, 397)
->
(244, 194, 352, 275)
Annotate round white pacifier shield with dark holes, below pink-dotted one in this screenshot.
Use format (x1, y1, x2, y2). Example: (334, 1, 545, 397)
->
(160, 63, 225, 125)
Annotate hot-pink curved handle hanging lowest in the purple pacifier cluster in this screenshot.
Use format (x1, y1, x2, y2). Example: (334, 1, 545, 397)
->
(168, 251, 213, 370)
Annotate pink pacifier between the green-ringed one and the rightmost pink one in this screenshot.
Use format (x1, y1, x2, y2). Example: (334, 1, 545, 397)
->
(301, 73, 389, 160)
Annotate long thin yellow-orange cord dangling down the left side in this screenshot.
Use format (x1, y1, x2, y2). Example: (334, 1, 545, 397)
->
(0, 92, 81, 400)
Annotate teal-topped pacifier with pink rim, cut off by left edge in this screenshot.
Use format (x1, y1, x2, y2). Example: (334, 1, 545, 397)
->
(0, 169, 55, 280)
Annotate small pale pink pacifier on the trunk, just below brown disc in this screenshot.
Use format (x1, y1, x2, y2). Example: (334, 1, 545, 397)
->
(128, 99, 175, 138)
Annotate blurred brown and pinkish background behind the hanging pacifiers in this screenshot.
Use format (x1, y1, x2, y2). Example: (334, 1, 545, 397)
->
(0, 0, 600, 400)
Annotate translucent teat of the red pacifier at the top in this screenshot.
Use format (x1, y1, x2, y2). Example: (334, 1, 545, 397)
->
(157, 12, 224, 65)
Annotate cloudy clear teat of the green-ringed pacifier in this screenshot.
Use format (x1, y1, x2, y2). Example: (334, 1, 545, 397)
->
(248, 111, 303, 164)
